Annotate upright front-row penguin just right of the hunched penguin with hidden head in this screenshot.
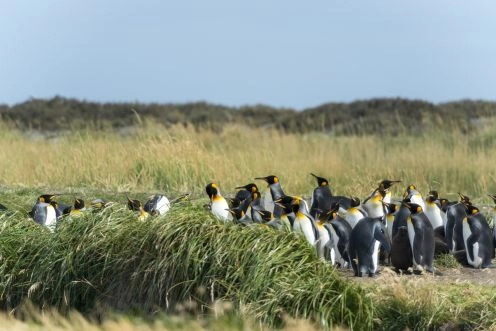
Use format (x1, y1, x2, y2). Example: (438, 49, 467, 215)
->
(407, 203, 435, 273)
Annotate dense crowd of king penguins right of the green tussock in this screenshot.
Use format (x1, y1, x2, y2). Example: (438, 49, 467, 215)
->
(206, 174, 496, 277)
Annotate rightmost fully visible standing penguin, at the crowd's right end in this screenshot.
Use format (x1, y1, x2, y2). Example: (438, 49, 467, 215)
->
(462, 206, 494, 269)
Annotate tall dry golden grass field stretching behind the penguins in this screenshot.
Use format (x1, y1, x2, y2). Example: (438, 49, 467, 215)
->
(0, 124, 496, 201)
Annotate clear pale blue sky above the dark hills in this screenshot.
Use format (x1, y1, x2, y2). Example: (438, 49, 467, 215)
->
(0, 0, 496, 109)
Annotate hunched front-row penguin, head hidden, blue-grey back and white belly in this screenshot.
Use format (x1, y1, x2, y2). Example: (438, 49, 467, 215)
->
(348, 217, 391, 277)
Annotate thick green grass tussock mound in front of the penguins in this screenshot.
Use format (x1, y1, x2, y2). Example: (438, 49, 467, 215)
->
(0, 203, 373, 329)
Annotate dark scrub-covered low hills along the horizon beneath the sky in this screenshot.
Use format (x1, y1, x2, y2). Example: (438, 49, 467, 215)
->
(0, 97, 496, 135)
